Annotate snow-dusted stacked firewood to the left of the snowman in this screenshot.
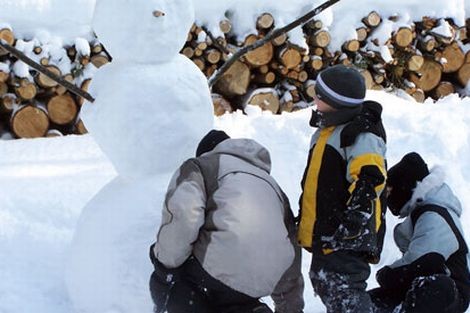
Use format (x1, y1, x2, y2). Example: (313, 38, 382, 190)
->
(0, 28, 111, 138)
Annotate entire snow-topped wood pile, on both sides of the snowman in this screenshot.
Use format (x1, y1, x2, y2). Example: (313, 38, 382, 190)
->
(0, 12, 470, 138)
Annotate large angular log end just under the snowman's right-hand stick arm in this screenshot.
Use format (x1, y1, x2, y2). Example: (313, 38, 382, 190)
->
(214, 61, 251, 97)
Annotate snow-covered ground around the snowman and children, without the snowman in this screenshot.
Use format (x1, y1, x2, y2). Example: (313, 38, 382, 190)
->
(0, 92, 470, 313)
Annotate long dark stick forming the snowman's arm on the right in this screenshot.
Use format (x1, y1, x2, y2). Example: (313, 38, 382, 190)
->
(209, 0, 341, 87)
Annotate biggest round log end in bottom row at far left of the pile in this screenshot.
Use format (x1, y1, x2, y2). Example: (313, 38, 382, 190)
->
(10, 105, 49, 138)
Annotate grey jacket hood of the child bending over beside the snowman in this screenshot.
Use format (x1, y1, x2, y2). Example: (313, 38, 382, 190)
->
(207, 138, 271, 173)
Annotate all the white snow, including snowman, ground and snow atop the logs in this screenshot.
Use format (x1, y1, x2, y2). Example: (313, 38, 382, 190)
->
(0, 0, 470, 313)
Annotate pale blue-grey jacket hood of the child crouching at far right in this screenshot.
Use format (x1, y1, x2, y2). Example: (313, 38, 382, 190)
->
(400, 166, 462, 217)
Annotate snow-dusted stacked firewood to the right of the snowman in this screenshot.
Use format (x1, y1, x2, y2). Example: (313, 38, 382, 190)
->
(182, 12, 470, 115)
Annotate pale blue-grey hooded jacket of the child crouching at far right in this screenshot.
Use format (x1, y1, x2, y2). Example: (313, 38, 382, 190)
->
(390, 167, 470, 268)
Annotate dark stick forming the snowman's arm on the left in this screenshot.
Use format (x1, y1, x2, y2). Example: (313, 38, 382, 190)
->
(0, 40, 95, 103)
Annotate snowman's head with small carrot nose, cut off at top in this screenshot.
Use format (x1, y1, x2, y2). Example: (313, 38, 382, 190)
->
(93, 0, 194, 63)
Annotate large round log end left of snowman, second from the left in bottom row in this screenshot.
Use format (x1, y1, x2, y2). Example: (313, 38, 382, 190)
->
(47, 94, 78, 125)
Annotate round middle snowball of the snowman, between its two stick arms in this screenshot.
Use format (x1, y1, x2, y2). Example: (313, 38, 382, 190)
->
(81, 55, 212, 177)
